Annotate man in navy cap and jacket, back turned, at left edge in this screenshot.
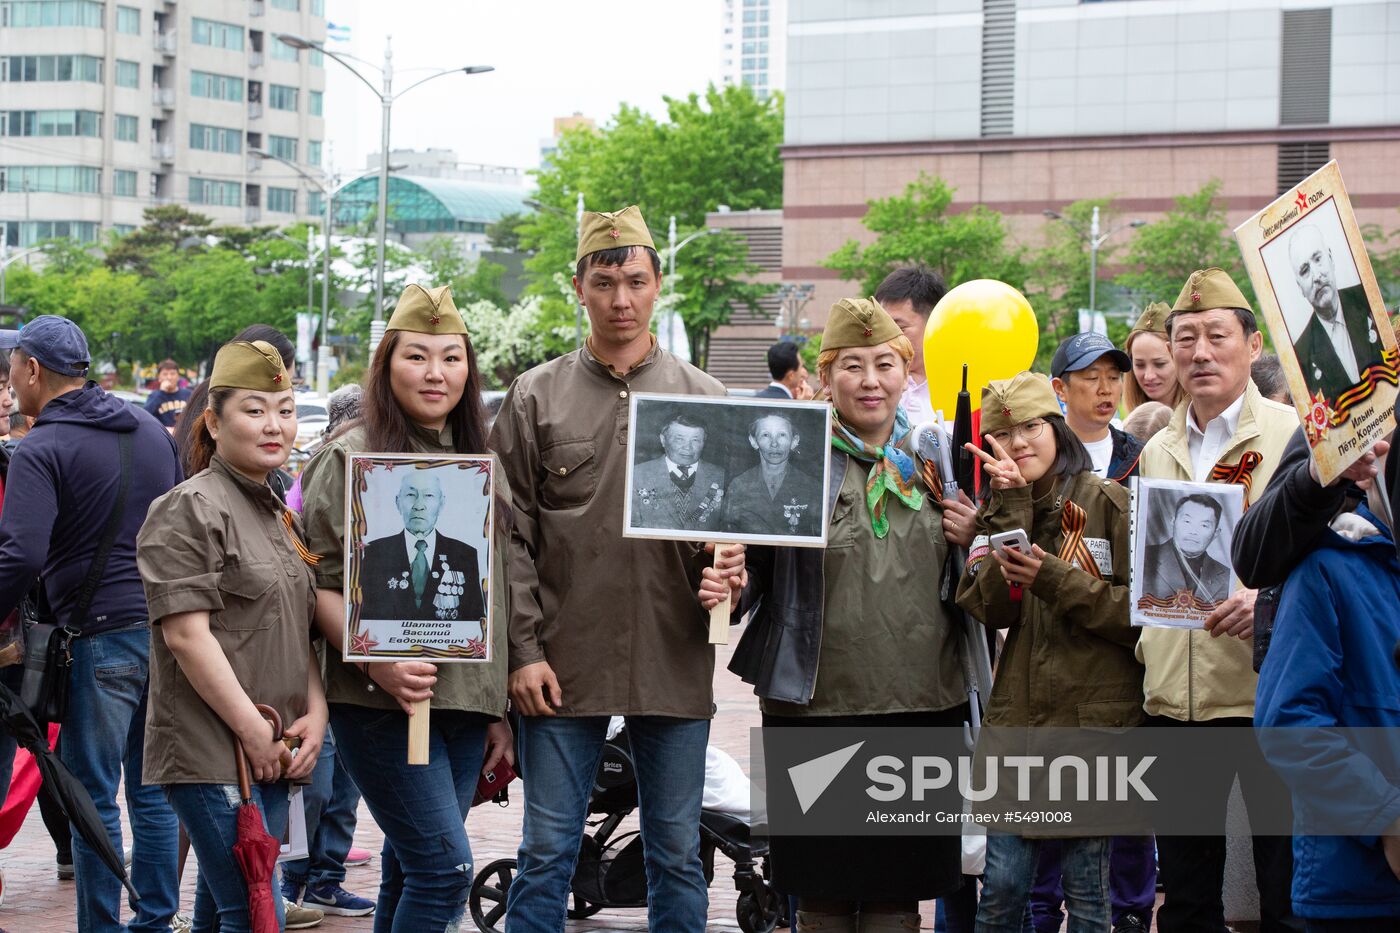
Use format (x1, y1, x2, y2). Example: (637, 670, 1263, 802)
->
(0, 315, 183, 933)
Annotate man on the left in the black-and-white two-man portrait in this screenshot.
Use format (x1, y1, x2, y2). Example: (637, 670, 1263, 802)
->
(631, 413, 724, 531)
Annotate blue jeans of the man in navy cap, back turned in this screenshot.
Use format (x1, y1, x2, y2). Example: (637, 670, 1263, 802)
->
(59, 622, 179, 933)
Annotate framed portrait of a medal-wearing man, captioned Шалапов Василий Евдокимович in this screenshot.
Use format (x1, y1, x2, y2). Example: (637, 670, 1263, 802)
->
(343, 454, 496, 663)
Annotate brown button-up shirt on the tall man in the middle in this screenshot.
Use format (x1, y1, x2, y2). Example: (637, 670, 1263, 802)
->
(491, 347, 724, 719)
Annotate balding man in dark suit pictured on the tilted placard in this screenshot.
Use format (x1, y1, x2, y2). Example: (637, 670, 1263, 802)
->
(1288, 224, 1382, 402)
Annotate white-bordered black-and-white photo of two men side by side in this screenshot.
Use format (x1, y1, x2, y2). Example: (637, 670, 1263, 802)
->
(623, 392, 832, 548)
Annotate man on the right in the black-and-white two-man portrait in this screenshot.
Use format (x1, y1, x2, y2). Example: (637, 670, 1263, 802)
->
(720, 413, 822, 535)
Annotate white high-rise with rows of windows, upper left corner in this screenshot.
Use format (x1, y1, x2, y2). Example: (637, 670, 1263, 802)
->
(0, 0, 326, 248)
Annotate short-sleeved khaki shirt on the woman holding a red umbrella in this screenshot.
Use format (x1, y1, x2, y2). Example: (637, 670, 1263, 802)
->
(136, 455, 316, 785)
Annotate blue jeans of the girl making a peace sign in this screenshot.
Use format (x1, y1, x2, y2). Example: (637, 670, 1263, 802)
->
(977, 834, 1112, 933)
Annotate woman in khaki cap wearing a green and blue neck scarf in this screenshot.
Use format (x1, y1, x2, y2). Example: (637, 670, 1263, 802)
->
(729, 298, 976, 933)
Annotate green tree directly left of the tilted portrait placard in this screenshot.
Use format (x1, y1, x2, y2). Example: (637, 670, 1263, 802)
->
(1117, 179, 1254, 305)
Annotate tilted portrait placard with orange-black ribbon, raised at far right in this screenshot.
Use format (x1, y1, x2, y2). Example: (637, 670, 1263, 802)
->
(1235, 161, 1400, 483)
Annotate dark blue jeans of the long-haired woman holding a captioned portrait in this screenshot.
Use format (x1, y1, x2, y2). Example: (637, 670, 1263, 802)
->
(330, 703, 486, 933)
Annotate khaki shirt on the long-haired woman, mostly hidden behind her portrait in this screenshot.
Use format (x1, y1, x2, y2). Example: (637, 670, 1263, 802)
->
(301, 427, 510, 717)
